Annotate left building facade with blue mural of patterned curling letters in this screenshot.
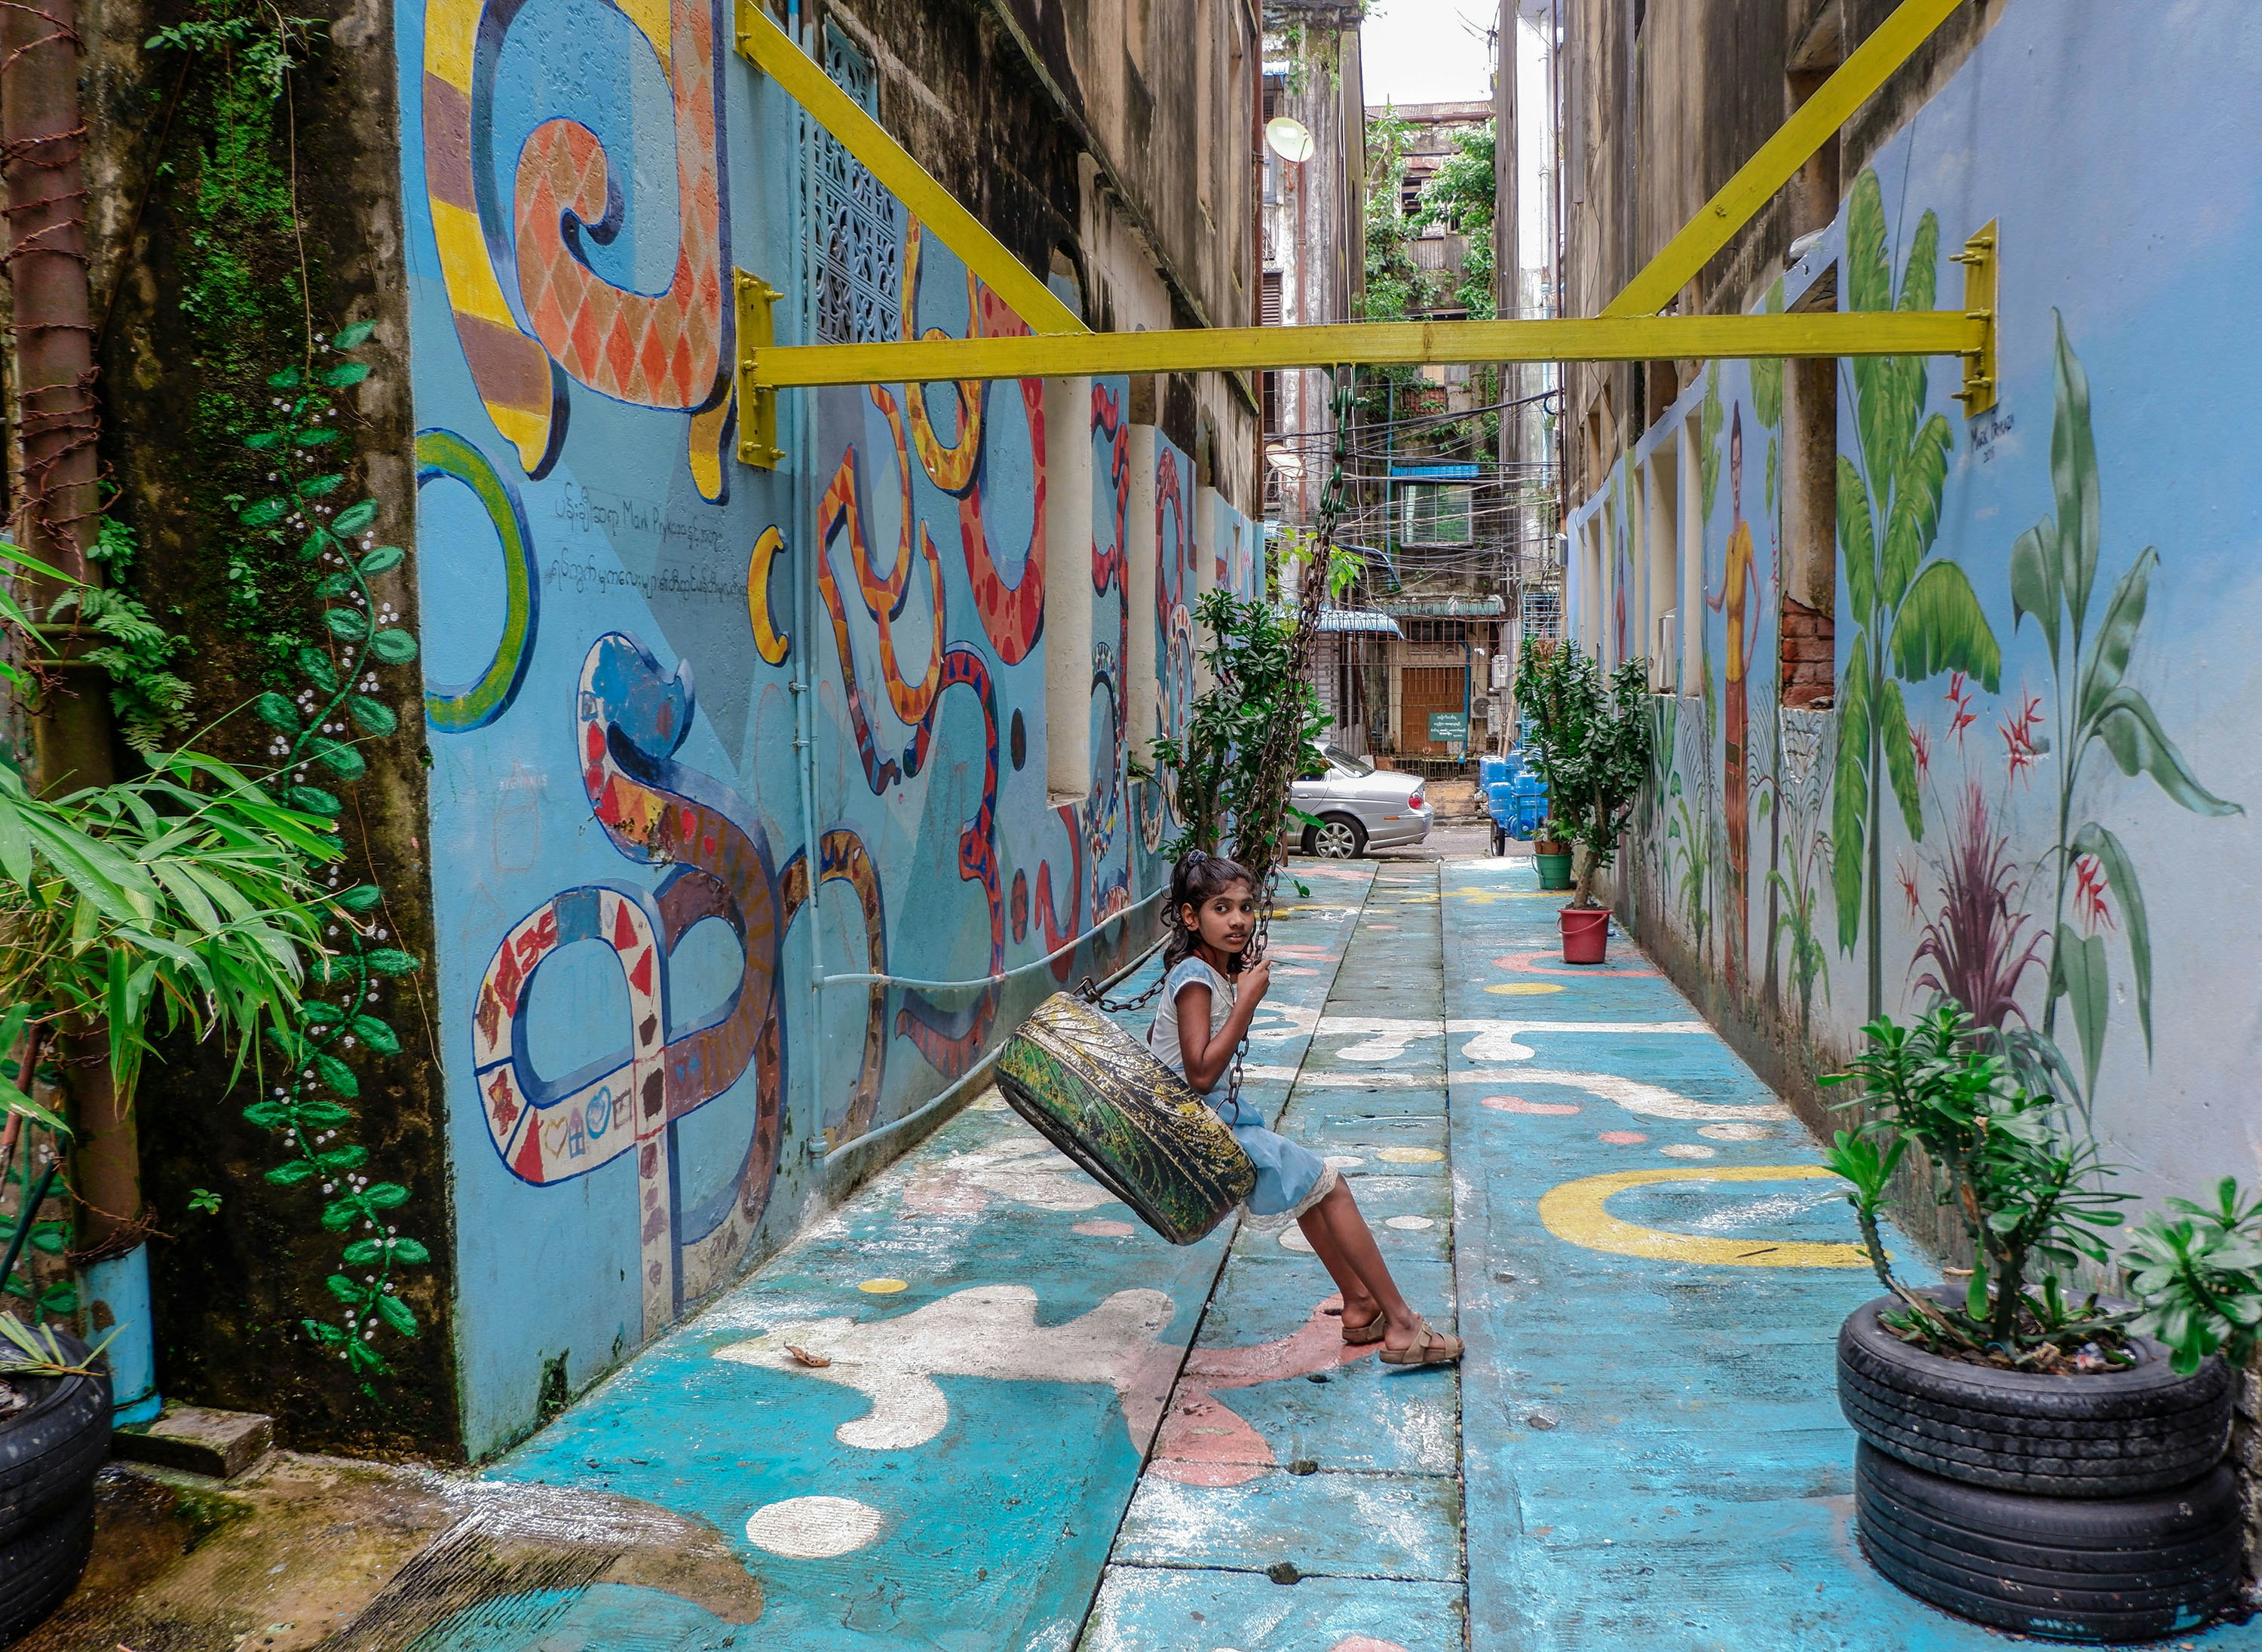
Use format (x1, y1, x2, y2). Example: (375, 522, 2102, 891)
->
(88, 0, 1264, 1457)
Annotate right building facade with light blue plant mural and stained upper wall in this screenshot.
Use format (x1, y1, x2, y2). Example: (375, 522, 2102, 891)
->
(1563, 0, 2262, 1502)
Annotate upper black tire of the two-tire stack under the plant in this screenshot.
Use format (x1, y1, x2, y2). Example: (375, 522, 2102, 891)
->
(1837, 1297, 2233, 1498)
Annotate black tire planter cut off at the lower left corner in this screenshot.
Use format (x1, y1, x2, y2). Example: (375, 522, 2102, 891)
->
(0, 1335, 111, 1645)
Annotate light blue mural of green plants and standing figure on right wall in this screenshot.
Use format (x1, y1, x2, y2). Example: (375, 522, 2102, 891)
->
(1570, 2, 2262, 1221)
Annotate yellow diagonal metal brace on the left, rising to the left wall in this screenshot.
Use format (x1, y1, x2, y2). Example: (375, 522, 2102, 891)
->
(737, 0, 1090, 333)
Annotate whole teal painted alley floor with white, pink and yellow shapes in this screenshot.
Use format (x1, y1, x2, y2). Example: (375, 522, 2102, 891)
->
(29, 858, 2262, 1652)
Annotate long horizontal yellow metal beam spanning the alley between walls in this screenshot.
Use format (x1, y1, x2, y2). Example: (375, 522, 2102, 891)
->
(740, 310, 1991, 387)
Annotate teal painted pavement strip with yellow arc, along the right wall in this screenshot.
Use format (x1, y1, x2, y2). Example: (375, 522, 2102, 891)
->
(1448, 860, 2262, 1652)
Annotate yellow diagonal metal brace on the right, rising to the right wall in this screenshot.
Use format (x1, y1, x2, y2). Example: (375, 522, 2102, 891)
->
(1601, 0, 1961, 317)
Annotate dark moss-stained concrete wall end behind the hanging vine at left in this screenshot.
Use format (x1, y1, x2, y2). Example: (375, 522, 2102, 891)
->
(81, 0, 461, 1455)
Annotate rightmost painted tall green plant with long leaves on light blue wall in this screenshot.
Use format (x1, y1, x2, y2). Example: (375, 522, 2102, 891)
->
(2004, 317, 2246, 1100)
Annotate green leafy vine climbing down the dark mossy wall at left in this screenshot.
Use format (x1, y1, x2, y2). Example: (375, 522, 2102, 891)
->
(134, 0, 432, 1392)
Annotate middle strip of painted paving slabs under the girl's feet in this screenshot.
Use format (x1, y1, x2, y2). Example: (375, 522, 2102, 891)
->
(1083, 863, 1466, 1652)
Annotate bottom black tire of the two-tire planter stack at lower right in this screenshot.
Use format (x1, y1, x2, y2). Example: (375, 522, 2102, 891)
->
(1855, 1444, 2242, 1641)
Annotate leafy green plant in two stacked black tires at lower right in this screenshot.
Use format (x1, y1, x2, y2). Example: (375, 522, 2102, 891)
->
(1825, 1003, 2262, 1641)
